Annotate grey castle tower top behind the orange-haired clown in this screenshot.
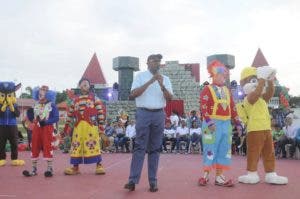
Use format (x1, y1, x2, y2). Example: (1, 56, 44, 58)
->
(207, 54, 235, 87)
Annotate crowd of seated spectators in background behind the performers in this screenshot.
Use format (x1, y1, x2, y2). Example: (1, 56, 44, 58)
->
(52, 106, 300, 158)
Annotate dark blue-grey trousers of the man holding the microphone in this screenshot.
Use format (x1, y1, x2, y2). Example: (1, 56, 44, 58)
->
(129, 108, 165, 184)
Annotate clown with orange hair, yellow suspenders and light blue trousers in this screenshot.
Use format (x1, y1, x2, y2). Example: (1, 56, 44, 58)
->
(198, 60, 240, 187)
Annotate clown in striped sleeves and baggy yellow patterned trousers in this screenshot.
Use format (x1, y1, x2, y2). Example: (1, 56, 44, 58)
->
(64, 79, 105, 175)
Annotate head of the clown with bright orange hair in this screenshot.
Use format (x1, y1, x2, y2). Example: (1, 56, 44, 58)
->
(207, 60, 229, 86)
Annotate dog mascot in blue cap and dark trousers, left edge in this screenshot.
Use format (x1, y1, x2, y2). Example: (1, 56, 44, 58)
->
(0, 82, 25, 166)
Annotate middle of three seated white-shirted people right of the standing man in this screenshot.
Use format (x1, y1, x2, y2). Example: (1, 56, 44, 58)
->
(176, 121, 190, 153)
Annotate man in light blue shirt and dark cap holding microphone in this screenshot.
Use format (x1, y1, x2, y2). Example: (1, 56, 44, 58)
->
(124, 54, 173, 192)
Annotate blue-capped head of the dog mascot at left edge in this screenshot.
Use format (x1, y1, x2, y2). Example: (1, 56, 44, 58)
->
(0, 82, 21, 104)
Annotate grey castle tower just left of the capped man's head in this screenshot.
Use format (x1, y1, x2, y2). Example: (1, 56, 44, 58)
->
(113, 56, 139, 100)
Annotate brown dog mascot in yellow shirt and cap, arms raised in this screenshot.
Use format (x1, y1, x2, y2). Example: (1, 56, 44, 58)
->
(238, 66, 288, 184)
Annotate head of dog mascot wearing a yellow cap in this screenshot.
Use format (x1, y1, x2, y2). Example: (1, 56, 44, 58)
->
(240, 67, 258, 95)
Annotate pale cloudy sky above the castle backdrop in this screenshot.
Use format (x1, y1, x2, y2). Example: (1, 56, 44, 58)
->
(0, 0, 300, 96)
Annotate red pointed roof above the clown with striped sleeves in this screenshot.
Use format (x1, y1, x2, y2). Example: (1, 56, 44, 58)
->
(82, 53, 106, 85)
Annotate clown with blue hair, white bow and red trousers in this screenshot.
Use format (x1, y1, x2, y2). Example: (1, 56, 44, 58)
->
(23, 86, 59, 177)
